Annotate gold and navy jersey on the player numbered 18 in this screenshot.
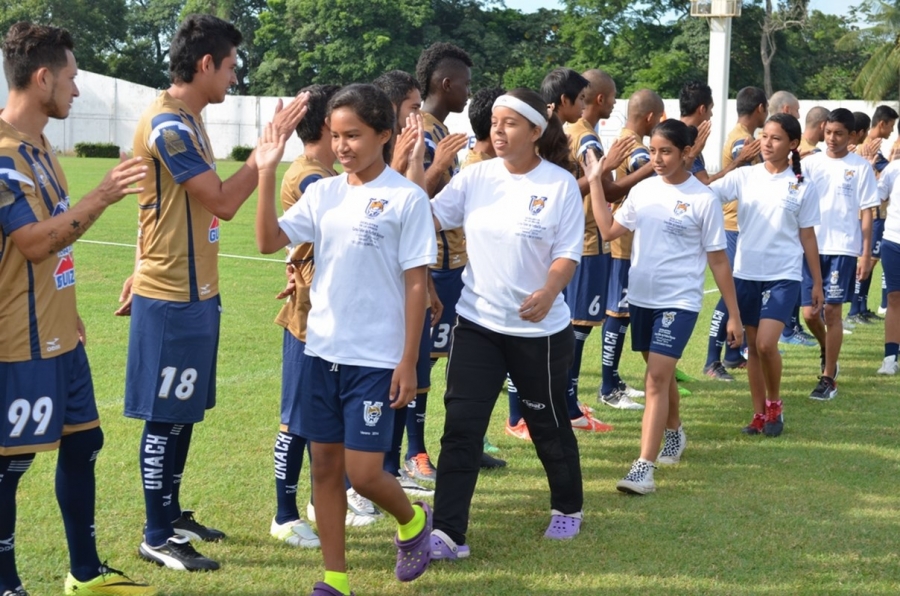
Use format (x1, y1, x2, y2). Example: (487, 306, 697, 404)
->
(133, 91, 219, 302)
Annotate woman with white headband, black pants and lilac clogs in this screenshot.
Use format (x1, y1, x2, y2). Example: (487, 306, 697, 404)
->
(431, 89, 584, 559)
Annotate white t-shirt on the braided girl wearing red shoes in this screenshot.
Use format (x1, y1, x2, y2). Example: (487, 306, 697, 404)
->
(709, 164, 820, 281)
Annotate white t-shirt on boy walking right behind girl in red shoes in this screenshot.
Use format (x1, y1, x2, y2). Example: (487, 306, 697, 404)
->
(801, 151, 881, 257)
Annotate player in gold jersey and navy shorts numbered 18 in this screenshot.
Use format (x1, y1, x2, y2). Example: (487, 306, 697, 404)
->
(120, 15, 305, 570)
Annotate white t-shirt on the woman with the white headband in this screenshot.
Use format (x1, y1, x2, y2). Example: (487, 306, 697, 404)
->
(431, 159, 584, 337)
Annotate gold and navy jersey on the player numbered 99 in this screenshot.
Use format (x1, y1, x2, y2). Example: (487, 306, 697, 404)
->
(0, 120, 78, 362)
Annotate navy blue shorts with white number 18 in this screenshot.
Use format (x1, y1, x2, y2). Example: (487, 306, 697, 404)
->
(125, 296, 222, 424)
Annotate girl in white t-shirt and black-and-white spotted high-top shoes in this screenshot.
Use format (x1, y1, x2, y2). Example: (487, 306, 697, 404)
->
(589, 120, 743, 495)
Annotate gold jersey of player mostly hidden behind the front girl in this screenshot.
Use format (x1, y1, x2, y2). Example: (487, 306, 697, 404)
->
(275, 155, 334, 342)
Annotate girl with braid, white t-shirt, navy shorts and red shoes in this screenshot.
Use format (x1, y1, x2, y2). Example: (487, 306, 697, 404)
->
(710, 114, 825, 437)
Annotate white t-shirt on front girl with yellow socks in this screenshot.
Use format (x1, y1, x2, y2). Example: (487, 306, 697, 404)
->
(278, 167, 437, 369)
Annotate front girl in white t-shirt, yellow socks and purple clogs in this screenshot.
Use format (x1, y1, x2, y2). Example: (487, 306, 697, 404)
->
(255, 85, 437, 596)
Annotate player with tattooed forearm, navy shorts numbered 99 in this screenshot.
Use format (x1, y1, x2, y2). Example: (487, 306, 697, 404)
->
(0, 22, 157, 596)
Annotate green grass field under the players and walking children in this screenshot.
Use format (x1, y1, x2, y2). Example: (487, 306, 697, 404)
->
(8, 158, 900, 596)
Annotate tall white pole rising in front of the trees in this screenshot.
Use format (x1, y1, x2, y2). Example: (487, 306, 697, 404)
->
(704, 17, 731, 172)
